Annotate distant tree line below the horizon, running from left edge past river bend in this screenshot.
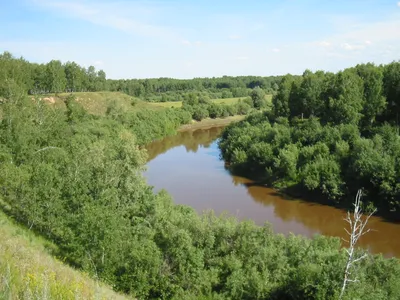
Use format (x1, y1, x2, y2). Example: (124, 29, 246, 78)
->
(0, 52, 281, 102)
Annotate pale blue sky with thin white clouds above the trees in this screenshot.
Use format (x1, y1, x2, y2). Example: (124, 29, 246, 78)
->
(0, 0, 400, 79)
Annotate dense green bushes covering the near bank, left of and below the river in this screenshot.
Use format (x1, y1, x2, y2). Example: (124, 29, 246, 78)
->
(0, 51, 400, 300)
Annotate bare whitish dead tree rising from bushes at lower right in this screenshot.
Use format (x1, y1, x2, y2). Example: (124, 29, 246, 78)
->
(339, 189, 376, 300)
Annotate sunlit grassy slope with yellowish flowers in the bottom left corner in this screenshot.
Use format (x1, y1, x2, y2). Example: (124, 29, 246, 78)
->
(0, 211, 127, 300)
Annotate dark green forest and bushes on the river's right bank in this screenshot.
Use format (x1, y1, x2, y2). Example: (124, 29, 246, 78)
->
(219, 62, 400, 213)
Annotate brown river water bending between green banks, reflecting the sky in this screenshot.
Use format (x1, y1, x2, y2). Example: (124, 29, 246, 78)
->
(144, 127, 400, 257)
